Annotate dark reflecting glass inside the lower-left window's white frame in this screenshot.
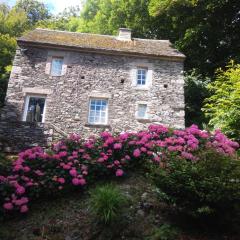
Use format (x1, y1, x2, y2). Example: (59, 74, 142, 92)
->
(26, 97, 45, 122)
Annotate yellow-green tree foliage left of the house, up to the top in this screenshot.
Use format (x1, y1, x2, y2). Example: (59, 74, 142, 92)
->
(0, 0, 50, 107)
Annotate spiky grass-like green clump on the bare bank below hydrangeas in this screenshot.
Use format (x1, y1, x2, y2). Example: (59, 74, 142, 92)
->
(90, 184, 126, 224)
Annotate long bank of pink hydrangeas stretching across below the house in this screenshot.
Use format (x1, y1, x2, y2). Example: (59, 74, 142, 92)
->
(0, 125, 239, 213)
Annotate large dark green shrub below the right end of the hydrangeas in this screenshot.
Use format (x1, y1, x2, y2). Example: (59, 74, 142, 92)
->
(152, 151, 240, 223)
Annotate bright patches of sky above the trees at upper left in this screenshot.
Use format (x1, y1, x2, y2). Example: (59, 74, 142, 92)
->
(0, 0, 81, 14)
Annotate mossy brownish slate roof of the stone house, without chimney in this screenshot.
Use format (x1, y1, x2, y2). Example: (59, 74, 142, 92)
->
(18, 28, 185, 61)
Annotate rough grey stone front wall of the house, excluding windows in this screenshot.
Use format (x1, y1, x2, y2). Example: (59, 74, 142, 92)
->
(0, 47, 184, 151)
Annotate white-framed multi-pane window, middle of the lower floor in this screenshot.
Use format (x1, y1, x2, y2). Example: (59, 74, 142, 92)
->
(88, 98, 108, 124)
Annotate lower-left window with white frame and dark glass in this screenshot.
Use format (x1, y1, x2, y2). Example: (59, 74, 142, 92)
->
(23, 95, 46, 123)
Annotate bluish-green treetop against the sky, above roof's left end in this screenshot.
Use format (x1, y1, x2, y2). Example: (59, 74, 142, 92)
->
(15, 0, 51, 26)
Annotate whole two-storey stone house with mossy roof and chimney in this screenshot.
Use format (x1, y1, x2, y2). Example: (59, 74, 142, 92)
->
(0, 28, 185, 151)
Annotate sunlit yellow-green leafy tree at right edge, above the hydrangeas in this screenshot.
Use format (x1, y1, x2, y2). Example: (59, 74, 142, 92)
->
(203, 61, 240, 140)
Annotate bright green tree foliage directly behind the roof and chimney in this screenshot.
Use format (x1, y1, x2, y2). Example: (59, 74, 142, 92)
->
(77, 0, 151, 37)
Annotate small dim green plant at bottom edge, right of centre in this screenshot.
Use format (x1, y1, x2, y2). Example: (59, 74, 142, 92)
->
(148, 224, 179, 240)
